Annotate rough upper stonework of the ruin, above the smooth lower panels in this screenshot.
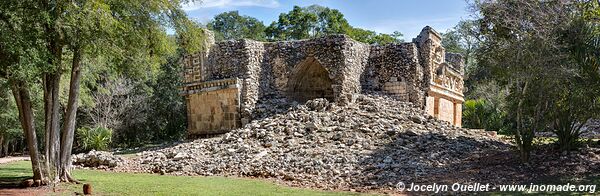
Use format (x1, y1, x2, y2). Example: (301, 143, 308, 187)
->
(184, 27, 463, 117)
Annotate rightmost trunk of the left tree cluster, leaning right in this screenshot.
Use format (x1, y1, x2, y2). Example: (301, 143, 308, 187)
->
(60, 48, 81, 182)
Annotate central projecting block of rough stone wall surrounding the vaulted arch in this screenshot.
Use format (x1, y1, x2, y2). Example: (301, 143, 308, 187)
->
(261, 35, 369, 104)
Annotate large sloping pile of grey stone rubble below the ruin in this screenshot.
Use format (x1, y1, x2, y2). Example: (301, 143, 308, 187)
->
(136, 95, 510, 189)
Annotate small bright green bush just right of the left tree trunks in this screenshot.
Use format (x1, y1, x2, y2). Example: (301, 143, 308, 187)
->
(77, 127, 113, 151)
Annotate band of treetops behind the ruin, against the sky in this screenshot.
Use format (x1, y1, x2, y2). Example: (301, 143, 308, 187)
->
(208, 5, 404, 44)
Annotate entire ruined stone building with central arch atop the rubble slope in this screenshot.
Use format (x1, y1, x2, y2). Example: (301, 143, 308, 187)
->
(182, 26, 464, 135)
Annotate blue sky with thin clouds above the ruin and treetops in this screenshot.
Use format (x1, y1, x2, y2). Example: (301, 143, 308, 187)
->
(183, 0, 469, 41)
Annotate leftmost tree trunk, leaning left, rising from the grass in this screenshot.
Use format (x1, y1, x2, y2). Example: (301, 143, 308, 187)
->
(12, 81, 46, 182)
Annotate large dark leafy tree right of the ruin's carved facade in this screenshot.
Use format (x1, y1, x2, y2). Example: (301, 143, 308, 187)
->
(475, 0, 598, 162)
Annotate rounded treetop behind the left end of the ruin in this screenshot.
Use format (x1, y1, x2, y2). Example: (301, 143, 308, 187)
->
(208, 11, 266, 41)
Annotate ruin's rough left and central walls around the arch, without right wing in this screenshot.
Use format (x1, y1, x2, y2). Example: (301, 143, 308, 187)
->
(184, 35, 370, 116)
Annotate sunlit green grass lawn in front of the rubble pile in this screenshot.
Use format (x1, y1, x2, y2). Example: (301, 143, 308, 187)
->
(0, 161, 368, 195)
